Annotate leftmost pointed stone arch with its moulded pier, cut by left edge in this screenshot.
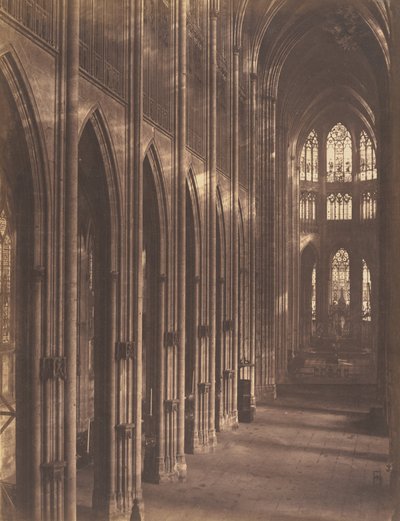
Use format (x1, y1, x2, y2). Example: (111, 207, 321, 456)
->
(0, 46, 52, 512)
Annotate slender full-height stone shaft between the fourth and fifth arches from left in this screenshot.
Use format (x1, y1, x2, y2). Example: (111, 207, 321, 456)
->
(208, 0, 219, 447)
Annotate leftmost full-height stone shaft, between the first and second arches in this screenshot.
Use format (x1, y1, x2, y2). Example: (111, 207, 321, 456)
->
(64, 0, 79, 521)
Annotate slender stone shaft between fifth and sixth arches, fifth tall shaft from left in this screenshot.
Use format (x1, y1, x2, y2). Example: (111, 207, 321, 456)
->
(231, 48, 240, 421)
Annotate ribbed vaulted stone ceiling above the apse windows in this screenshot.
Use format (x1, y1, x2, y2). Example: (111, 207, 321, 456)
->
(237, 0, 390, 144)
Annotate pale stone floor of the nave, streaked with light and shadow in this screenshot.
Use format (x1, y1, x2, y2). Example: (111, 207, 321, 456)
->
(76, 386, 390, 521)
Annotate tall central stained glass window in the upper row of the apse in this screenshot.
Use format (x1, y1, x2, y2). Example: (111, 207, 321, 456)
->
(326, 123, 352, 183)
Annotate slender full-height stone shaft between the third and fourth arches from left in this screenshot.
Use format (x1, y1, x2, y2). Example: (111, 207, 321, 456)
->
(176, 0, 187, 479)
